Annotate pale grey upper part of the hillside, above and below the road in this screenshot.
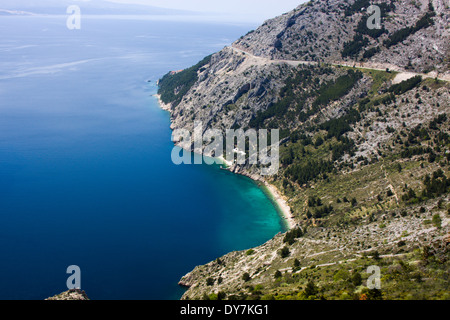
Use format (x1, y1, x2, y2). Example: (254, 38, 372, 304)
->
(160, 0, 450, 139)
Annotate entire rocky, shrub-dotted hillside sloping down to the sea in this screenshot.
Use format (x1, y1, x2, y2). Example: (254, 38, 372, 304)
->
(159, 0, 450, 299)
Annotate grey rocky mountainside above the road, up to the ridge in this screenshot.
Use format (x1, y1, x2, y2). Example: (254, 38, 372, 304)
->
(233, 0, 450, 73)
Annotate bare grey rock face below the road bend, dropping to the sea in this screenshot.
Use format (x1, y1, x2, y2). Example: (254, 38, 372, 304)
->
(167, 48, 292, 134)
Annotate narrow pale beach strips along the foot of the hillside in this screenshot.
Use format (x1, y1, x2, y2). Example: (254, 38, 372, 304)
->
(154, 94, 297, 231)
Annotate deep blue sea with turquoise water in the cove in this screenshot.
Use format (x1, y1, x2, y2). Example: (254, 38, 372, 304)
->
(0, 17, 284, 300)
